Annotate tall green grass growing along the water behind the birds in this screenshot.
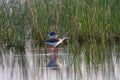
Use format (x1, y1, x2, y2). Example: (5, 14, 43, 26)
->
(0, 0, 120, 49)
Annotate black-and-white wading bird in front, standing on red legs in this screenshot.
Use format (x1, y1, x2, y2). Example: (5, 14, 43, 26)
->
(44, 37, 68, 60)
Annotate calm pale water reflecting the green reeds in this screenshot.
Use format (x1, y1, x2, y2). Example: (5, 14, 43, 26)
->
(0, 44, 120, 80)
